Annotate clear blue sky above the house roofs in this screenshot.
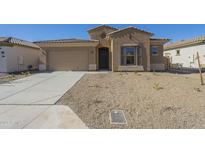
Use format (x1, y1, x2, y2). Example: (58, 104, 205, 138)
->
(0, 24, 205, 41)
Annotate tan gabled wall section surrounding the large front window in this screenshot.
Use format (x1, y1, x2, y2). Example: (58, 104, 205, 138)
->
(111, 32, 150, 71)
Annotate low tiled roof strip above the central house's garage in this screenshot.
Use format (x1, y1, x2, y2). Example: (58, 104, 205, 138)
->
(34, 38, 99, 43)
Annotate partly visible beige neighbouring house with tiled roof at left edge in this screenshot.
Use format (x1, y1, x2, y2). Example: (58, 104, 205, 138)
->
(0, 37, 45, 73)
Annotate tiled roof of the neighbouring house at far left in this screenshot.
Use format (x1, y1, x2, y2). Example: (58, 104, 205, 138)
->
(0, 37, 40, 49)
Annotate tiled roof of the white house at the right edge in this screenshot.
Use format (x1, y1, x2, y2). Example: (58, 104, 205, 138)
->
(164, 36, 205, 50)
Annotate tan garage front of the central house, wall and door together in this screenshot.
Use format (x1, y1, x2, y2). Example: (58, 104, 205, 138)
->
(43, 47, 96, 70)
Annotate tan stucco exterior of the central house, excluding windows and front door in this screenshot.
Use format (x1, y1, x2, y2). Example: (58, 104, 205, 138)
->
(34, 27, 167, 71)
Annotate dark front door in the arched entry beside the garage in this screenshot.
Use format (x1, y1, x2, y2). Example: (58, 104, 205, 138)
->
(99, 48, 109, 69)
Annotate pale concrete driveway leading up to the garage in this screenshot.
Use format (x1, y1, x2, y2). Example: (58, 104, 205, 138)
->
(0, 72, 87, 128)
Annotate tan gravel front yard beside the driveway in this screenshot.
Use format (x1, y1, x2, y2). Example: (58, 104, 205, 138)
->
(58, 72, 205, 128)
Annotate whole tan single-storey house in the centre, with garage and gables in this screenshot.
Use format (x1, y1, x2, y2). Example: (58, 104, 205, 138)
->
(34, 25, 169, 71)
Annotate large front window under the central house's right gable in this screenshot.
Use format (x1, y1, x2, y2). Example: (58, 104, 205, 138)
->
(121, 46, 137, 66)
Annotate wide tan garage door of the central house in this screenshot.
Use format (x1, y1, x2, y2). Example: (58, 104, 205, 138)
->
(48, 49, 88, 71)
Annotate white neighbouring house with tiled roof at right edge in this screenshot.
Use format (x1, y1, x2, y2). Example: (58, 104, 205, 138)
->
(164, 36, 205, 69)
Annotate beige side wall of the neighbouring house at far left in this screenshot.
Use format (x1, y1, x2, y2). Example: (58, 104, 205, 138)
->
(4, 46, 41, 72)
